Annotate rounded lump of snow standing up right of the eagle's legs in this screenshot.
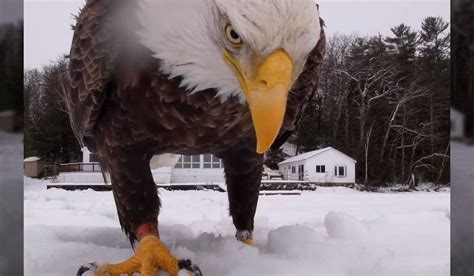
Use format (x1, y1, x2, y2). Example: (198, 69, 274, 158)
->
(324, 212, 370, 239)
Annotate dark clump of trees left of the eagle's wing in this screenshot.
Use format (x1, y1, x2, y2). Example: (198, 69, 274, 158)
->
(25, 60, 80, 163)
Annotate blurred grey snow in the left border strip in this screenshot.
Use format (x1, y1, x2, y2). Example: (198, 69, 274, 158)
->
(0, 131, 23, 275)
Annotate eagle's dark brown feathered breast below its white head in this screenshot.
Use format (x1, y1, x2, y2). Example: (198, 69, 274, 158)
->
(98, 67, 255, 154)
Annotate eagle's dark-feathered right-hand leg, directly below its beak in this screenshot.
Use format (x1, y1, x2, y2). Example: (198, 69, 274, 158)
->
(220, 149, 263, 245)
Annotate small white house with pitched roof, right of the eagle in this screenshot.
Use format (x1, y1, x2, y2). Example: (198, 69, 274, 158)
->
(278, 147, 357, 184)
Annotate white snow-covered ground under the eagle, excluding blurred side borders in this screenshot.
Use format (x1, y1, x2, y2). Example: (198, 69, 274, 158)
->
(24, 178, 450, 276)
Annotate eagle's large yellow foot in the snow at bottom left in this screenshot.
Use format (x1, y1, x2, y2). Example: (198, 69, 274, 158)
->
(95, 235, 180, 276)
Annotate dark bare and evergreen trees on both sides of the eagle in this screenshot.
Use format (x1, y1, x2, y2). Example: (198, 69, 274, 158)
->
(24, 17, 450, 186)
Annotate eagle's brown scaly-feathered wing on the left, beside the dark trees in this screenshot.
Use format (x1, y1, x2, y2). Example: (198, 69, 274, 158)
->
(65, 0, 119, 151)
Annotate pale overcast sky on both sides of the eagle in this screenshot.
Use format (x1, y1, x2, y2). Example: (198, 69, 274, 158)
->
(24, 0, 450, 68)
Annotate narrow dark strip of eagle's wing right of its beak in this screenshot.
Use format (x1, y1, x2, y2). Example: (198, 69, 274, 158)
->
(271, 20, 326, 150)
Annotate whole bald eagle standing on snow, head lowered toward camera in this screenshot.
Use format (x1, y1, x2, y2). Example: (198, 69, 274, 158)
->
(65, 0, 325, 275)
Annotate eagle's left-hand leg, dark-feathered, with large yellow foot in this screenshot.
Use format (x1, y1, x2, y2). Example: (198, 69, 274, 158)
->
(88, 144, 201, 276)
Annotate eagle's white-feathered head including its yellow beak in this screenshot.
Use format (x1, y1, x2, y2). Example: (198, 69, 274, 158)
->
(139, 0, 321, 152)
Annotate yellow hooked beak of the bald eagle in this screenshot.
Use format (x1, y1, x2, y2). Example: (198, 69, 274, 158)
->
(224, 50, 293, 154)
